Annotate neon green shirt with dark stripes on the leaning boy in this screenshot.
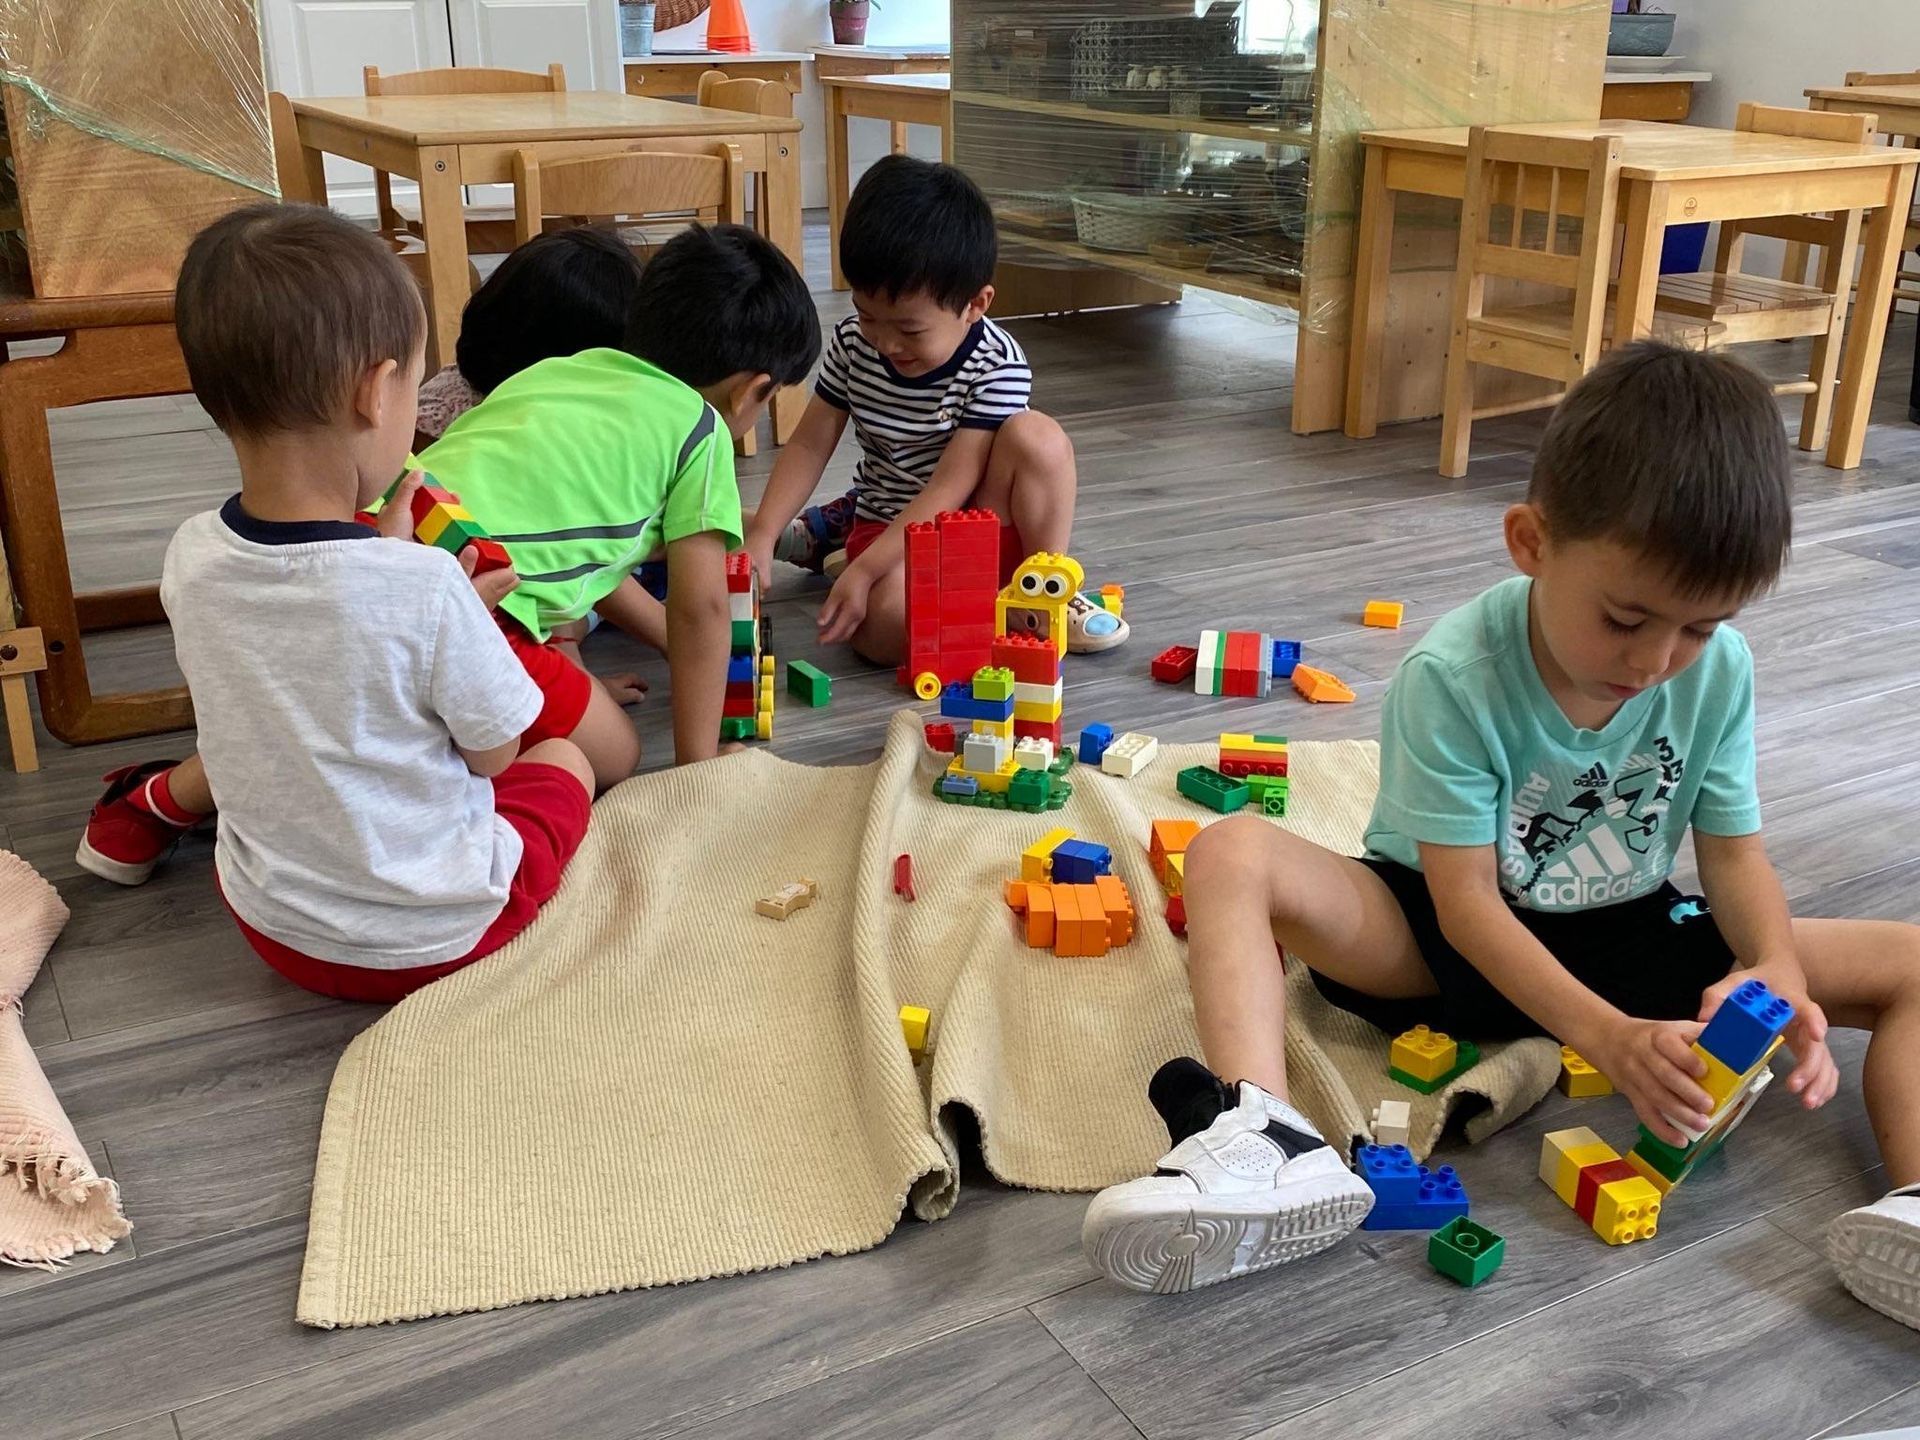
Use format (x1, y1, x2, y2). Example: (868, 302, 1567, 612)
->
(420, 349, 741, 639)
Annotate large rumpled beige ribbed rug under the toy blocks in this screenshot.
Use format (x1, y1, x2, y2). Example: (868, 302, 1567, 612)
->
(298, 712, 1557, 1327)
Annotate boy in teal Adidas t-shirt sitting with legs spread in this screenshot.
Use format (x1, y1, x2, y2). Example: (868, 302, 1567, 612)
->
(1083, 342, 1920, 1325)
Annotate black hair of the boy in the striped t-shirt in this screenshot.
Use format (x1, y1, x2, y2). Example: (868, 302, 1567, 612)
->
(841, 156, 1000, 315)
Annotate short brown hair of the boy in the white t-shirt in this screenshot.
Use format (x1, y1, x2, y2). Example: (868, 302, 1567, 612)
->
(175, 204, 426, 436)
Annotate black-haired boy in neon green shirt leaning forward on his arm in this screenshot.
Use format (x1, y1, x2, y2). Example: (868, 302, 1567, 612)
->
(420, 225, 820, 789)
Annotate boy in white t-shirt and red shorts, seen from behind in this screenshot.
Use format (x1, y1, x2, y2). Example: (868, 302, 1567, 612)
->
(79, 205, 593, 1000)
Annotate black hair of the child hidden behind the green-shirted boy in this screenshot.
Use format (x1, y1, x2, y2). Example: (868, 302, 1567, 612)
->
(453, 225, 639, 396)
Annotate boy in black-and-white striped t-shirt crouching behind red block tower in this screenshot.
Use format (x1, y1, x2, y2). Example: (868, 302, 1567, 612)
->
(747, 156, 1127, 664)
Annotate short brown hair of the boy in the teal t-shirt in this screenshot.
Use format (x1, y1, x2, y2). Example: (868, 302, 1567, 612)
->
(1526, 340, 1793, 599)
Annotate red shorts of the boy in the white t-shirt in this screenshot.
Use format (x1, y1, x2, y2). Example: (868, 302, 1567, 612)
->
(221, 764, 593, 1004)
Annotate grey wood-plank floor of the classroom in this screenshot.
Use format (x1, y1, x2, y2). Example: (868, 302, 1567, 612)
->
(0, 216, 1920, 1440)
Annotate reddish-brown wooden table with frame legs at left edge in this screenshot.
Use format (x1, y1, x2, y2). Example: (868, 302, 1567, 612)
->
(0, 290, 194, 745)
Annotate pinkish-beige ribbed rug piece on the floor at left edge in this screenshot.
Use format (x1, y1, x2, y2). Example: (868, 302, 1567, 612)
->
(0, 851, 132, 1269)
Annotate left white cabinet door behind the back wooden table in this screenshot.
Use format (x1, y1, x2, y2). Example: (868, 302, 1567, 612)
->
(263, 0, 453, 215)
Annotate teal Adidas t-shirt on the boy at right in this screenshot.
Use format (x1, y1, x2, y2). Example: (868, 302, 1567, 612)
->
(1367, 576, 1761, 910)
